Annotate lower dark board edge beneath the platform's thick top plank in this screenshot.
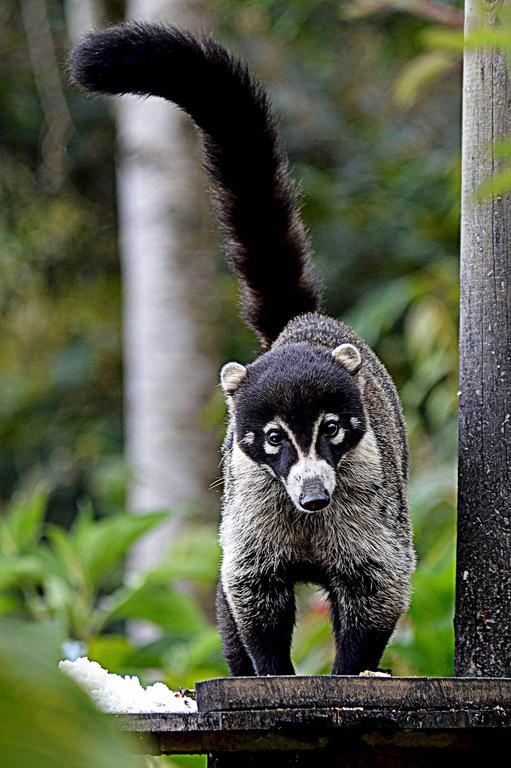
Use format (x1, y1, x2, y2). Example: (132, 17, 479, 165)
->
(117, 706, 511, 754)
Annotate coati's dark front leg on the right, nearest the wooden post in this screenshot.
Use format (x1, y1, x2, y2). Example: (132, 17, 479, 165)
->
(330, 590, 402, 675)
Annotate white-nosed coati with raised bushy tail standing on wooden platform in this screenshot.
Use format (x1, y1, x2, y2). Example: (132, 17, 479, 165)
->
(70, 23, 415, 675)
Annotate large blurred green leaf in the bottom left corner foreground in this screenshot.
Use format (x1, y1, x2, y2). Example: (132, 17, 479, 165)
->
(0, 619, 136, 768)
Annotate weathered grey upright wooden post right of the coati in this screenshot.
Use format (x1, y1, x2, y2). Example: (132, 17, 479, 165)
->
(455, 0, 511, 677)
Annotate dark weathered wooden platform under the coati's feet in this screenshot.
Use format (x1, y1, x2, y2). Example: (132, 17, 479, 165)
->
(118, 676, 511, 768)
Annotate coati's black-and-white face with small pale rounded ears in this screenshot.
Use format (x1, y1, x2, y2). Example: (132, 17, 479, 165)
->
(221, 343, 366, 512)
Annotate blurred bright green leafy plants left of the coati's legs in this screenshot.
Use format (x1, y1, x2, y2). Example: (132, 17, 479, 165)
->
(0, 490, 225, 687)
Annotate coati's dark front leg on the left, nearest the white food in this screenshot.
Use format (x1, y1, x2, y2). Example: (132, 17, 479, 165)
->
(220, 571, 295, 675)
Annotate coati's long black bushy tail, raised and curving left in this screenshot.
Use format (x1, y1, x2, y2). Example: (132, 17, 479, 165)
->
(69, 23, 319, 346)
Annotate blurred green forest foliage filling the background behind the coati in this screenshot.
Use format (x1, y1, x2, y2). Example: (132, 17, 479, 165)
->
(0, 7, 466, 765)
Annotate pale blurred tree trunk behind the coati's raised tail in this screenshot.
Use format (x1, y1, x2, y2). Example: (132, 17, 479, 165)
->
(117, 0, 215, 641)
